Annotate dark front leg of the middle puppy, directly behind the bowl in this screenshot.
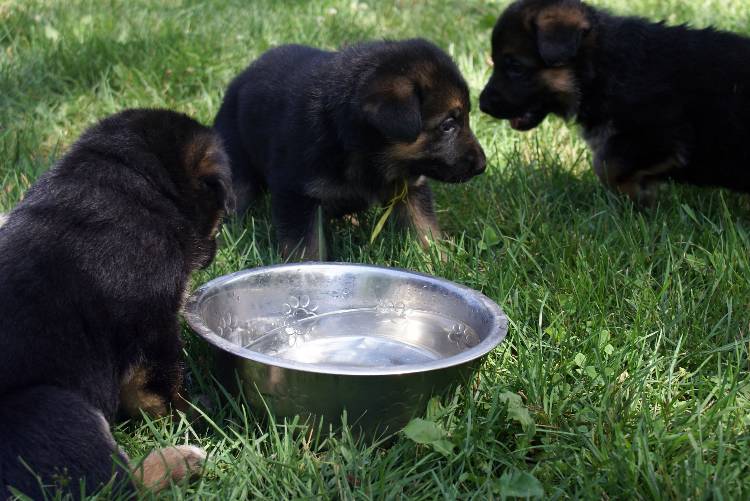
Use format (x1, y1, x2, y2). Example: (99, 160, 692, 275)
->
(271, 193, 328, 261)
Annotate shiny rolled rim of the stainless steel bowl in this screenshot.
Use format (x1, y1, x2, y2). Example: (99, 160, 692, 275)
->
(182, 261, 509, 376)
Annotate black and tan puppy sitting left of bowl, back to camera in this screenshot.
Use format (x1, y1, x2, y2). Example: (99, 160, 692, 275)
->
(0, 110, 232, 499)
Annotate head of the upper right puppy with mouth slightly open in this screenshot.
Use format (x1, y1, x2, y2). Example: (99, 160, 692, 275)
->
(479, 0, 594, 131)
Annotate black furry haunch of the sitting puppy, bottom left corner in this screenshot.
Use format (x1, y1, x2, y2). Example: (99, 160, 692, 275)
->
(0, 386, 136, 499)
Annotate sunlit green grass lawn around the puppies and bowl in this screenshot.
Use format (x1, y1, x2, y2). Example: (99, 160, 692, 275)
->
(0, 0, 750, 500)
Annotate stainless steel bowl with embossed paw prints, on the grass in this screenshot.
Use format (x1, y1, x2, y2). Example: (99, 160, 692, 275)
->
(185, 263, 508, 434)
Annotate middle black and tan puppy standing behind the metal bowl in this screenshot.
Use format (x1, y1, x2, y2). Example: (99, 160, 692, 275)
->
(215, 39, 485, 259)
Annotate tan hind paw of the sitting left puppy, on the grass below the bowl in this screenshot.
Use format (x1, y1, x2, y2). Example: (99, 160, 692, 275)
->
(133, 445, 206, 493)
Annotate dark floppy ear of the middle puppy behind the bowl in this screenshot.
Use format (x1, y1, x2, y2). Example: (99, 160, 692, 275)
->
(362, 76, 422, 143)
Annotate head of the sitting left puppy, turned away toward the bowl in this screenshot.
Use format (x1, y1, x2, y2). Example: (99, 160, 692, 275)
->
(115, 110, 235, 267)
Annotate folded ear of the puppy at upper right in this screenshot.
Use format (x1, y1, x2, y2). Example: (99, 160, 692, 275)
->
(535, 2, 591, 67)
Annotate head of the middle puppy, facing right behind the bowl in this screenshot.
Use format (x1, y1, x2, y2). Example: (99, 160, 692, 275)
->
(358, 40, 486, 182)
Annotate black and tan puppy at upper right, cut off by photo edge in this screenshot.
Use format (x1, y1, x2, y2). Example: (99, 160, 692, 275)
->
(480, 0, 750, 203)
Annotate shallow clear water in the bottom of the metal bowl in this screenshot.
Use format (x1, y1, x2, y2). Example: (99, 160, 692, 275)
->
(228, 308, 479, 368)
